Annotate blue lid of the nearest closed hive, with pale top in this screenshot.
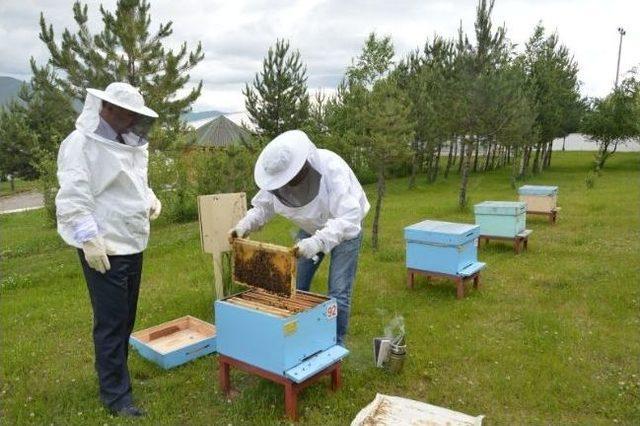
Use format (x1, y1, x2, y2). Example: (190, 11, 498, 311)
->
(404, 220, 480, 245)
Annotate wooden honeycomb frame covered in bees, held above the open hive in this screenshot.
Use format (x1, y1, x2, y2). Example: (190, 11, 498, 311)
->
(233, 238, 296, 297)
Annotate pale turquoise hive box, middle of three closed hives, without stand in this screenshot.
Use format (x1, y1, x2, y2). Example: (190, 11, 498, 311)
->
(473, 201, 527, 238)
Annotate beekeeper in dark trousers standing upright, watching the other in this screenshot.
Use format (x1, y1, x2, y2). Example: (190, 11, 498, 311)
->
(56, 83, 161, 417)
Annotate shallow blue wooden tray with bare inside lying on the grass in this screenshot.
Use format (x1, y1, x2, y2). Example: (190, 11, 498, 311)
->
(129, 316, 216, 369)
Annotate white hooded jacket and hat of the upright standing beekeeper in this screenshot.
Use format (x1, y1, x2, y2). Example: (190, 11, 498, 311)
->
(56, 83, 160, 256)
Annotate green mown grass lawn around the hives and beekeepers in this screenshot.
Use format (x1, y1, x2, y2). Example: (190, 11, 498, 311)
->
(0, 153, 640, 425)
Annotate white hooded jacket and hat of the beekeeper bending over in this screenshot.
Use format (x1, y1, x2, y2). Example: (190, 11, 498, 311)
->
(235, 130, 370, 253)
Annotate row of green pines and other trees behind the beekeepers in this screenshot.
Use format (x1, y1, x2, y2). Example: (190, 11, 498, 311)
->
(0, 0, 640, 247)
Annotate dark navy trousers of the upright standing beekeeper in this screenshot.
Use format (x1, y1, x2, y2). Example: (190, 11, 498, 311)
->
(78, 250, 142, 410)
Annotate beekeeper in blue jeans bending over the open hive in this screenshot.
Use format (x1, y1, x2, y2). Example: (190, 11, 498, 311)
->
(230, 130, 370, 345)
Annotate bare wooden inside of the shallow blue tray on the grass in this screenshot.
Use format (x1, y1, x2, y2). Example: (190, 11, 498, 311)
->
(131, 315, 216, 354)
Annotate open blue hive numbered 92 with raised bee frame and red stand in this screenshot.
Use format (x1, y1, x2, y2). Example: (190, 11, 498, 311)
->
(215, 239, 349, 420)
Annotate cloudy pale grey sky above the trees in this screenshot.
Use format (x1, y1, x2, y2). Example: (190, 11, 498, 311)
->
(0, 0, 640, 112)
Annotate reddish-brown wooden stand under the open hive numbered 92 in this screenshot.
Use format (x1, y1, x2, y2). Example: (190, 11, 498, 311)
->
(218, 355, 341, 421)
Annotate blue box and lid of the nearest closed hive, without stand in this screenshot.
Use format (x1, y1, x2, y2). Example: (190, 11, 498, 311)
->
(404, 220, 484, 275)
